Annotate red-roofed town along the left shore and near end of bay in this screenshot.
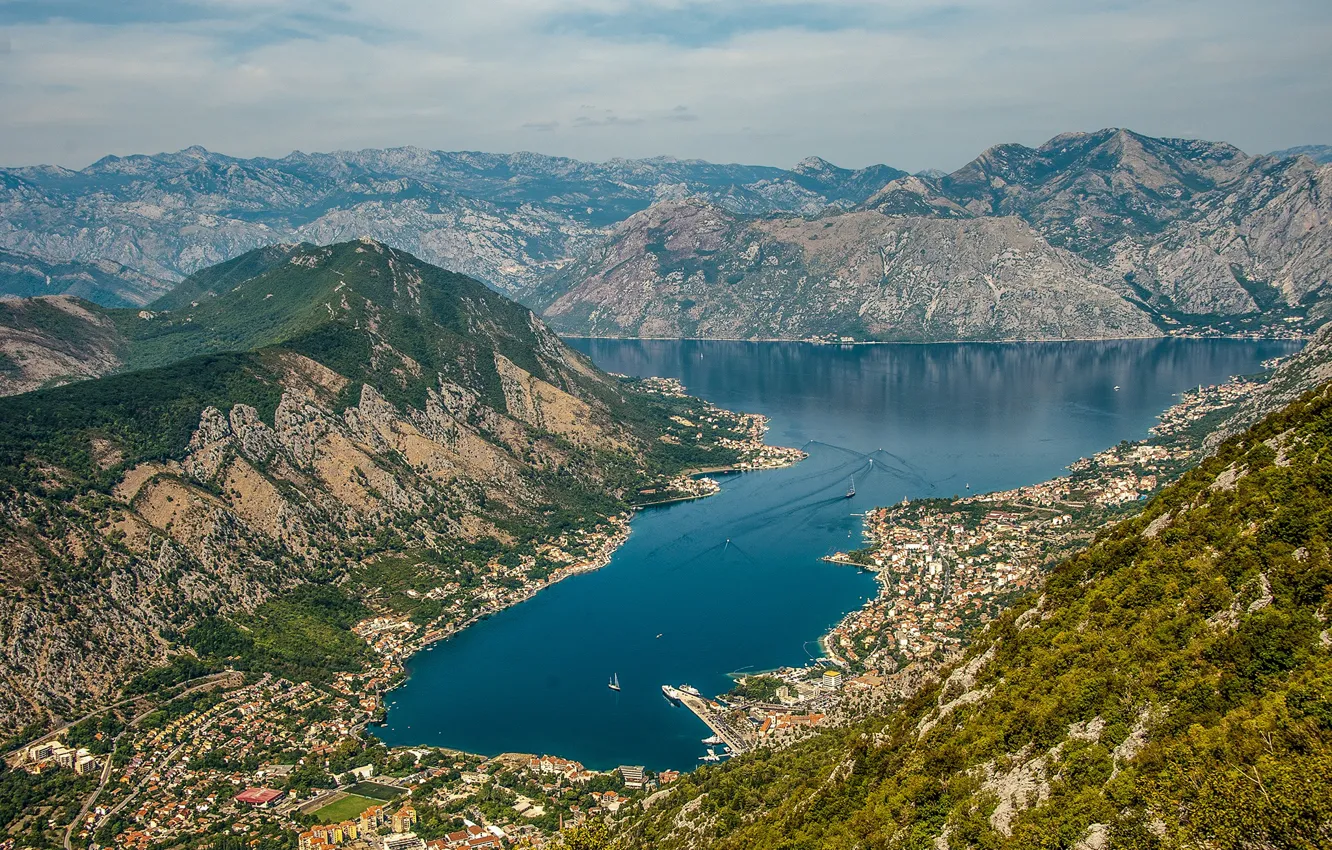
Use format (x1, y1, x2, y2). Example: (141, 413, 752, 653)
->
(0, 378, 805, 850)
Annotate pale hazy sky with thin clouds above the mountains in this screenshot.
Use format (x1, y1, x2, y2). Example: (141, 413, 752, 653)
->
(0, 0, 1332, 171)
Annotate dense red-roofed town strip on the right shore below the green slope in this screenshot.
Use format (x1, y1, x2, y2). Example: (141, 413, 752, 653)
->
(823, 370, 1261, 675)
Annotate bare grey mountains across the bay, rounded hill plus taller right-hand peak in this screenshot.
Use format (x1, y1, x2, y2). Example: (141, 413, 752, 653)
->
(535, 129, 1332, 338)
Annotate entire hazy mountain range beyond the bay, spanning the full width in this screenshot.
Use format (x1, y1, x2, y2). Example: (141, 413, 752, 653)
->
(0, 129, 1332, 340)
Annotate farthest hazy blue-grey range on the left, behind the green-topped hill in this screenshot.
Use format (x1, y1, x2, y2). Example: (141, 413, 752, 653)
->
(0, 147, 902, 292)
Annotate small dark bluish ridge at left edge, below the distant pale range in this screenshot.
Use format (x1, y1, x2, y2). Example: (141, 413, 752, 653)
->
(0, 248, 170, 306)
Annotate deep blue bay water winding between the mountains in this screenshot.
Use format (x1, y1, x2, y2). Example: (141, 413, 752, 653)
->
(376, 340, 1296, 770)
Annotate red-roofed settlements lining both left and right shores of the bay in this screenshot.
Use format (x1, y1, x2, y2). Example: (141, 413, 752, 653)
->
(0, 381, 1257, 850)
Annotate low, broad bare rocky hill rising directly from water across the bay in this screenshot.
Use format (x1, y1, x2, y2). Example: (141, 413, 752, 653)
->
(534, 201, 1156, 340)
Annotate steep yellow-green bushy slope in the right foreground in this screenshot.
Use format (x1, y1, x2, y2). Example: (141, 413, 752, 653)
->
(615, 385, 1332, 850)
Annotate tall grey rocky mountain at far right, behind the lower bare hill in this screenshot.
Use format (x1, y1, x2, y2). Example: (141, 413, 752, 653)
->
(866, 129, 1332, 325)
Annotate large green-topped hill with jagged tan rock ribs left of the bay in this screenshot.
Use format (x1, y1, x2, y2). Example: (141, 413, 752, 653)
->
(0, 240, 703, 733)
